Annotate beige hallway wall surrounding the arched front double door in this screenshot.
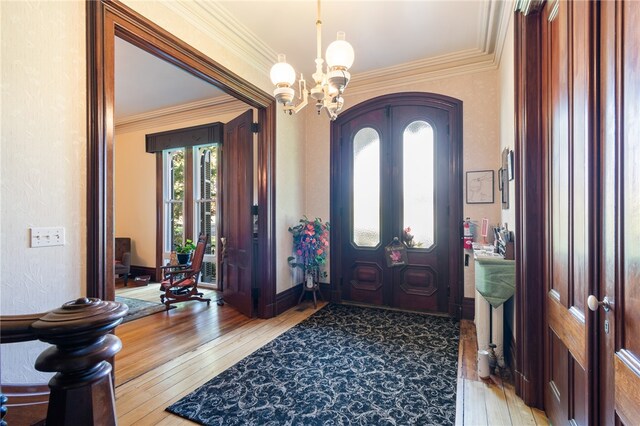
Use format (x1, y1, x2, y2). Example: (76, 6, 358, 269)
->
(305, 70, 500, 297)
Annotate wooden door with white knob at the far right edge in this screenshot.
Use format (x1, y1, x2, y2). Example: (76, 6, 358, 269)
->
(592, 1, 640, 425)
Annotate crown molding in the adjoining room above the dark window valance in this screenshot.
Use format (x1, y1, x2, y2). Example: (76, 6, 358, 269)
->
(115, 95, 249, 133)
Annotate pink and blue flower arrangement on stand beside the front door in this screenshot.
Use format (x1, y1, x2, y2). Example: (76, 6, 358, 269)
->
(287, 216, 329, 288)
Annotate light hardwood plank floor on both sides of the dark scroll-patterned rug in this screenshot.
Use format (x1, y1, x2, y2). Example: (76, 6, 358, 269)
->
(116, 284, 548, 426)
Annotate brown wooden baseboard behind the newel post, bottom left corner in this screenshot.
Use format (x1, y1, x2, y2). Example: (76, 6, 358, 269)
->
(2, 383, 50, 425)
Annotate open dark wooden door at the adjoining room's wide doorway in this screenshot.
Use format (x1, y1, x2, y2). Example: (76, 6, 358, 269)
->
(220, 110, 254, 317)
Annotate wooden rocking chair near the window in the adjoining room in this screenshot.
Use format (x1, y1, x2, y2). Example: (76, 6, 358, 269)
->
(160, 234, 211, 310)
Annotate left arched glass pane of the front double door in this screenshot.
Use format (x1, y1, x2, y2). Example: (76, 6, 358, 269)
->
(352, 127, 380, 247)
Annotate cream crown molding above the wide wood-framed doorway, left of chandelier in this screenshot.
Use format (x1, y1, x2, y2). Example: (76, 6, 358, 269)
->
(166, 0, 277, 74)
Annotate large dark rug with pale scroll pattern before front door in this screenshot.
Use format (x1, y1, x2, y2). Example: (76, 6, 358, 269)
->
(167, 305, 460, 425)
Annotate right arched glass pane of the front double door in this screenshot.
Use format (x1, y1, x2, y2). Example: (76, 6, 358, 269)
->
(402, 121, 435, 248)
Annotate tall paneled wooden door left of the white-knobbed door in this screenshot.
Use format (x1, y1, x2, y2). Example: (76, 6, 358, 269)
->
(541, 1, 597, 424)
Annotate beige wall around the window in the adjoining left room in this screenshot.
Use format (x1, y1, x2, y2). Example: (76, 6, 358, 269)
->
(114, 105, 249, 267)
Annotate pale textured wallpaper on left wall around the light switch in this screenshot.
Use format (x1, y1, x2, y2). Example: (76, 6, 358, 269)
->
(0, 1, 86, 383)
